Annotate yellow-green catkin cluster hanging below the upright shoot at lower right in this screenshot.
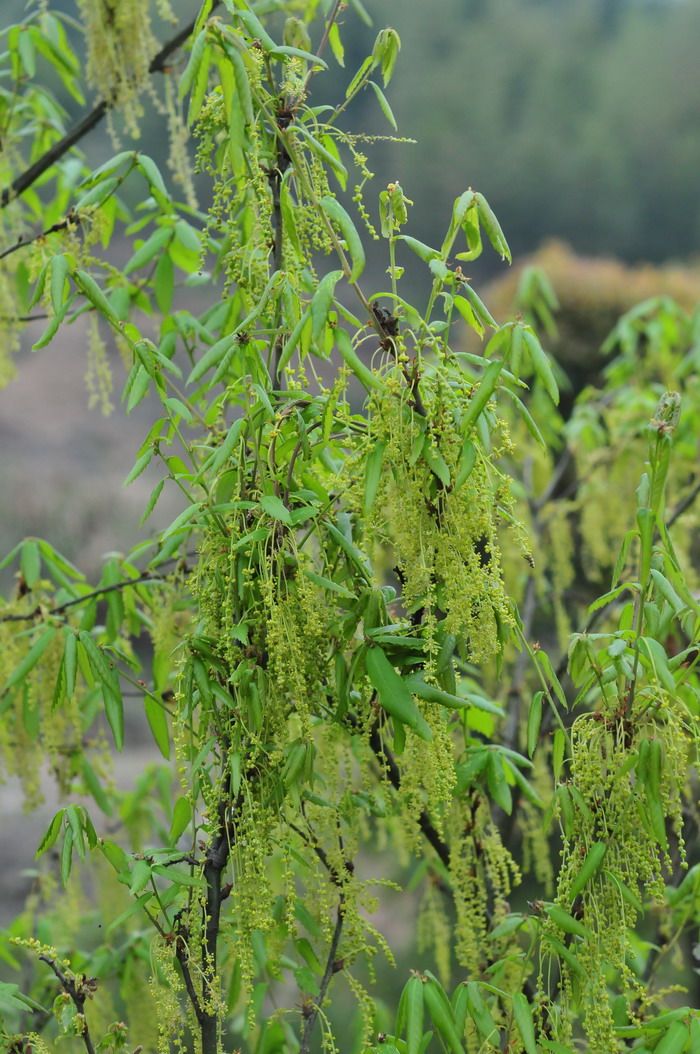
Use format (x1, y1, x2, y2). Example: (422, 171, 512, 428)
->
(545, 686, 689, 1051)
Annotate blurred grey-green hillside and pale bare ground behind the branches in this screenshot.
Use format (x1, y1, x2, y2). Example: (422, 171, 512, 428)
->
(0, 0, 700, 571)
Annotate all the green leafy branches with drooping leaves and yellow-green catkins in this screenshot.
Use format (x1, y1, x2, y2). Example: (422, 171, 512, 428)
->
(0, 0, 700, 1054)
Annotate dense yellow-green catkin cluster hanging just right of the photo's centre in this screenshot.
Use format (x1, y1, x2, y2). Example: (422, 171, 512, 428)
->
(368, 369, 512, 662)
